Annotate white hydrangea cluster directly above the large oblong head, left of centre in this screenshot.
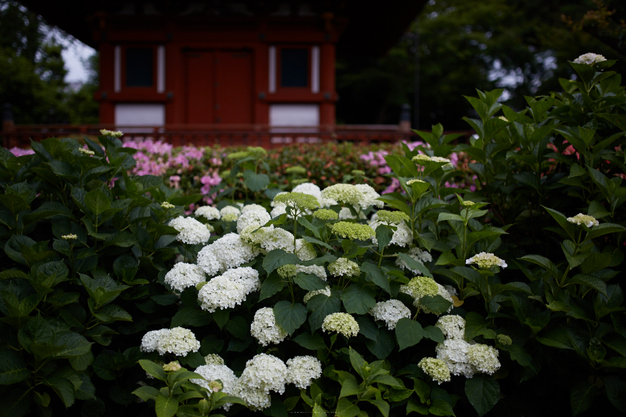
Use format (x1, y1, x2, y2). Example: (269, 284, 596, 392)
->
(197, 233, 260, 276)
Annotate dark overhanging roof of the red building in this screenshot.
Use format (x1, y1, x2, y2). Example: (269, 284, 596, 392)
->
(20, 0, 427, 58)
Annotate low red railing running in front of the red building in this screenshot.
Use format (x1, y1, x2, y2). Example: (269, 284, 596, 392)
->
(0, 125, 424, 149)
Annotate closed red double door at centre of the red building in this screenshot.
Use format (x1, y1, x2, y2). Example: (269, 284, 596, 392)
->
(185, 49, 253, 124)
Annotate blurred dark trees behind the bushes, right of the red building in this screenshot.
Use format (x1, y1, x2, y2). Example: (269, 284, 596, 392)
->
(337, 0, 624, 130)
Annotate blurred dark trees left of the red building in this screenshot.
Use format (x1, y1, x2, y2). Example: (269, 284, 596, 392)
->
(0, 0, 98, 124)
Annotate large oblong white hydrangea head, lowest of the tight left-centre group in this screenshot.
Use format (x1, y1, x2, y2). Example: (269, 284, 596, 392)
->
(198, 267, 261, 313)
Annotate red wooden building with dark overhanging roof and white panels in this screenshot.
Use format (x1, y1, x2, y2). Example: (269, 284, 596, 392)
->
(11, 0, 426, 147)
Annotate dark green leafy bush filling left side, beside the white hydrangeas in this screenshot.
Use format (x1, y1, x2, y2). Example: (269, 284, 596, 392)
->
(0, 137, 183, 417)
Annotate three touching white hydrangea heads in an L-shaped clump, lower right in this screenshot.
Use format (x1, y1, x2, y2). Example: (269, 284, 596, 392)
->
(436, 316, 500, 378)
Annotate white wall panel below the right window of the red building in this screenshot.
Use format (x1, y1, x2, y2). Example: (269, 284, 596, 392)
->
(270, 104, 320, 143)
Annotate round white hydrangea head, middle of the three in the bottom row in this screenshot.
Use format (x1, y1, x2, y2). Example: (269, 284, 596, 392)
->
(239, 353, 287, 394)
